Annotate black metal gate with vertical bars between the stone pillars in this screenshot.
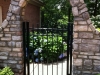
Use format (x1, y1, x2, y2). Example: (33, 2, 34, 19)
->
(23, 22, 73, 75)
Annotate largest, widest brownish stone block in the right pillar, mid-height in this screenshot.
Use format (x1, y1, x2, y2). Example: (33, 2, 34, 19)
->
(79, 44, 99, 52)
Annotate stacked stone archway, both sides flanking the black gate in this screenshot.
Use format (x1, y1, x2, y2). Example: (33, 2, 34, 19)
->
(0, 0, 100, 75)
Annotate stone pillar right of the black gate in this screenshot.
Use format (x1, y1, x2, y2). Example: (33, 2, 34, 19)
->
(70, 0, 100, 75)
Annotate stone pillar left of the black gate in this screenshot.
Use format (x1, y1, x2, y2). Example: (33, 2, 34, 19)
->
(0, 0, 26, 75)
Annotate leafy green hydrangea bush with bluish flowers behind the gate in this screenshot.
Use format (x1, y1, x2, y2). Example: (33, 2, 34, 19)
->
(30, 32, 67, 62)
